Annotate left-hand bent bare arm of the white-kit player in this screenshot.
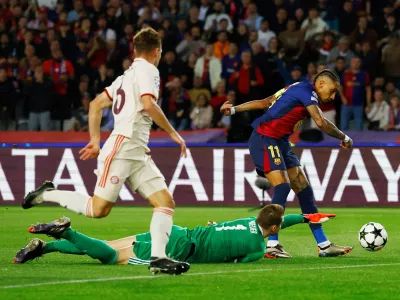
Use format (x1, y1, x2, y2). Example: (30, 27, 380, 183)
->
(79, 92, 112, 160)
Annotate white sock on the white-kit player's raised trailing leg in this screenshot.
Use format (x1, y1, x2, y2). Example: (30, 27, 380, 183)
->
(43, 190, 93, 217)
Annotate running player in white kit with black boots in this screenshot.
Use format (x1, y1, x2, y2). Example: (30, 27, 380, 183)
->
(22, 28, 190, 275)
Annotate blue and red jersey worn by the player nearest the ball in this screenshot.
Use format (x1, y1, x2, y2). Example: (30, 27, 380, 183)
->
(251, 81, 318, 139)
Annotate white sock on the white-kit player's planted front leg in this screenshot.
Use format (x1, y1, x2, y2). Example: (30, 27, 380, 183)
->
(150, 207, 174, 257)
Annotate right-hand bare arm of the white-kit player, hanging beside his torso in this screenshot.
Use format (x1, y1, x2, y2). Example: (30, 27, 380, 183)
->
(142, 95, 186, 157)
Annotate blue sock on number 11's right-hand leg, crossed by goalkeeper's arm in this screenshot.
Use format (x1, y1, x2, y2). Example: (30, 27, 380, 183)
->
(297, 186, 330, 246)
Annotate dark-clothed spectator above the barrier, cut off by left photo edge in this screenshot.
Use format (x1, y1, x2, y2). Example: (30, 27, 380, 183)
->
(0, 68, 17, 131)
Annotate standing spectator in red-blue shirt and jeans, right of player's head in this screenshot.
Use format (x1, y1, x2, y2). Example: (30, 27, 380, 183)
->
(340, 57, 371, 131)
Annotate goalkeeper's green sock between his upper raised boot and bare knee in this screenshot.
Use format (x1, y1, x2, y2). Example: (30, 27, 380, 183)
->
(61, 228, 118, 265)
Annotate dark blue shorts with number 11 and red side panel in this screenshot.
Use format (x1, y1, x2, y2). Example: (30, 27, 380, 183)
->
(249, 131, 300, 175)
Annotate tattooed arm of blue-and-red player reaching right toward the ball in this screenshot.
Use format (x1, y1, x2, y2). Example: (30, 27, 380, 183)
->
(307, 105, 353, 148)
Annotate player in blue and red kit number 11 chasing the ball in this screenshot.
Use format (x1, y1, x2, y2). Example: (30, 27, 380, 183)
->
(221, 69, 353, 258)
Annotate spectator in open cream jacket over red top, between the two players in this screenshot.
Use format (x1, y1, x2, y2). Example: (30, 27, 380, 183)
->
(194, 44, 222, 91)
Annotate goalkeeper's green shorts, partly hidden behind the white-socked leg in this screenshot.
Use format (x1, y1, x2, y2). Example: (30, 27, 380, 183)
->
(130, 225, 195, 264)
